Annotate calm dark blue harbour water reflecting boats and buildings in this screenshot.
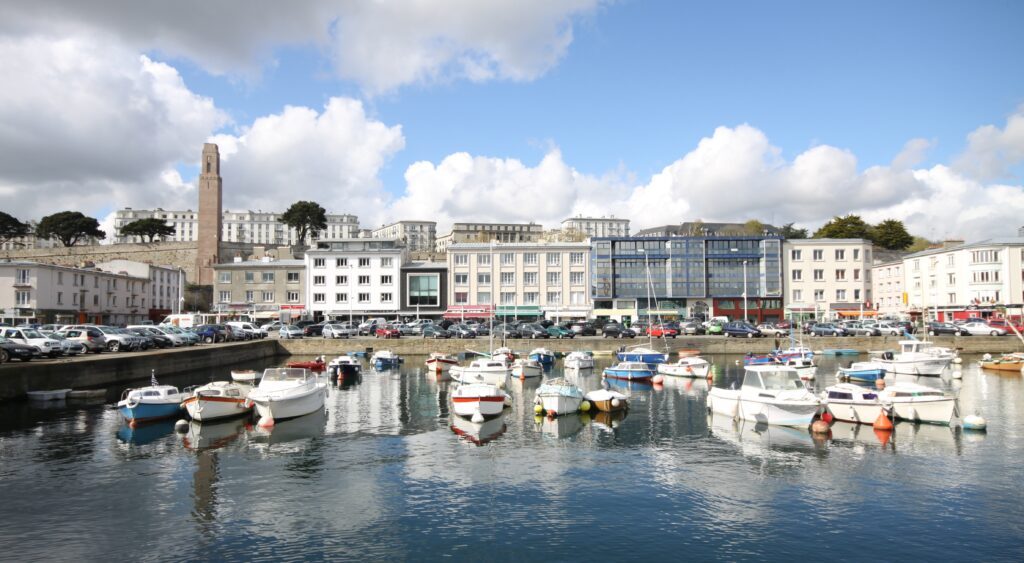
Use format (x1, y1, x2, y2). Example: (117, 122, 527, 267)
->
(0, 356, 1024, 561)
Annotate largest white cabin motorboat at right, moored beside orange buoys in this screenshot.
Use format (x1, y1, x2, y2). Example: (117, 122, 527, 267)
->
(708, 365, 821, 426)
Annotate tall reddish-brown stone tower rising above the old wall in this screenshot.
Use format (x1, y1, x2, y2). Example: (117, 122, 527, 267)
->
(196, 142, 223, 286)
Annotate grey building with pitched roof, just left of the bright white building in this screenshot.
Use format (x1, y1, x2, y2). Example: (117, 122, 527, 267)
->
(213, 256, 308, 320)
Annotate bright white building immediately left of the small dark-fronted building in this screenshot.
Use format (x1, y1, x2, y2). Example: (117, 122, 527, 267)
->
(305, 239, 408, 319)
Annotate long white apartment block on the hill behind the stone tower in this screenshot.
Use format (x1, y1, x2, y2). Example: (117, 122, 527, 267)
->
(113, 208, 359, 245)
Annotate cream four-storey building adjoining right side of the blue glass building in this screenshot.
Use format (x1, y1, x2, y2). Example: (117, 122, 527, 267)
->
(782, 239, 874, 318)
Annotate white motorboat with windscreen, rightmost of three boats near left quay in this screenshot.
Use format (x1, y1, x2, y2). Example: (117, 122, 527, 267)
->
(248, 367, 327, 421)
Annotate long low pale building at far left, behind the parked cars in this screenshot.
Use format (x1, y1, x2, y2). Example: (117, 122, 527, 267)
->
(0, 261, 153, 324)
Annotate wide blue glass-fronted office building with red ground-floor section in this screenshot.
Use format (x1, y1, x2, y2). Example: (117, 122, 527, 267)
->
(591, 235, 782, 321)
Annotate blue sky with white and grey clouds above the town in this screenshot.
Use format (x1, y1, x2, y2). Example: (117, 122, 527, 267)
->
(0, 0, 1024, 237)
